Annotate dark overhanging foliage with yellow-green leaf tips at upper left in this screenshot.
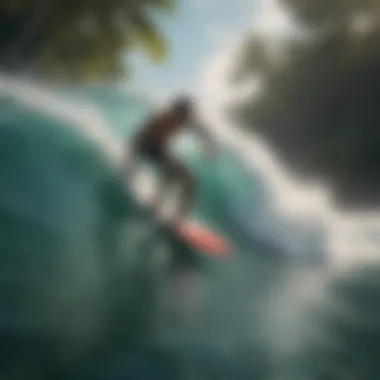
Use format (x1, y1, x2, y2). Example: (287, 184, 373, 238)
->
(0, 0, 173, 81)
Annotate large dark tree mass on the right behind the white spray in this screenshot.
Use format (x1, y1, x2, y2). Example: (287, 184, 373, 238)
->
(233, 0, 380, 207)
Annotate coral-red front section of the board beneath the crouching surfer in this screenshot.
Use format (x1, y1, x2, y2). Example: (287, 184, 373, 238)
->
(173, 222, 231, 257)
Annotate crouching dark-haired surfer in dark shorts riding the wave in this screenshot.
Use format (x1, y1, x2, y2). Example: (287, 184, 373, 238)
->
(129, 96, 215, 222)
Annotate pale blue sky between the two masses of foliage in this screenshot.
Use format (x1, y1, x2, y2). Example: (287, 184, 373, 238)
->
(130, 0, 259, 99)
